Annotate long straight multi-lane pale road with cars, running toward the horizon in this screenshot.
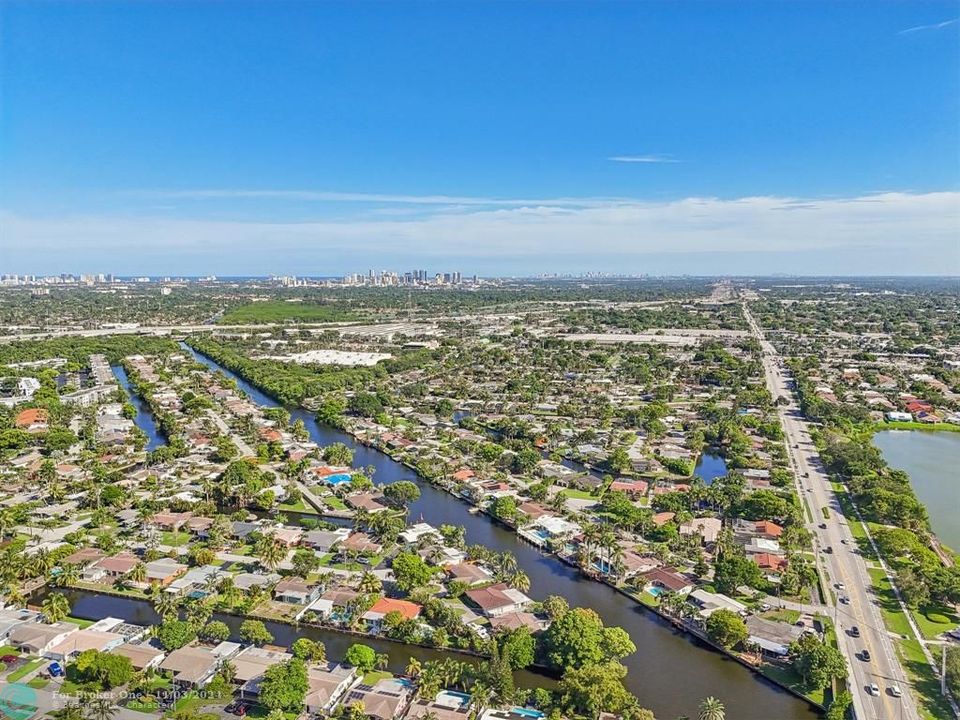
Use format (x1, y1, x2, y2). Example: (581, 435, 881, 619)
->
(743, 304, 920, 720)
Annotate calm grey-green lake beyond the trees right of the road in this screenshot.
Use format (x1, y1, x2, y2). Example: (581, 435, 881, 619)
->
(873, 430, 960, 550)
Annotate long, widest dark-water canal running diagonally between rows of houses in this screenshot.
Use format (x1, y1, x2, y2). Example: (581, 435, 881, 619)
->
(169, 345, 818, 720)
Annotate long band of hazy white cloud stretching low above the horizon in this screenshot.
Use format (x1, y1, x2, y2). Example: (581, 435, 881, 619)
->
(0, 192, 960, 274)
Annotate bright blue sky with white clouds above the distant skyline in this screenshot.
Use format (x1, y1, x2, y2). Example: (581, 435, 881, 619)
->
(0, 2, 960, 274)
